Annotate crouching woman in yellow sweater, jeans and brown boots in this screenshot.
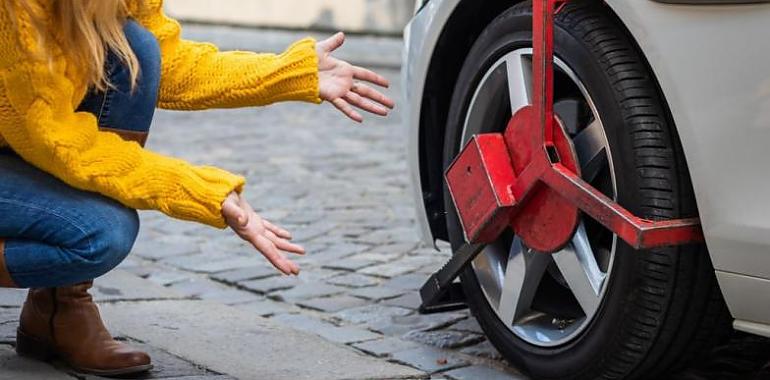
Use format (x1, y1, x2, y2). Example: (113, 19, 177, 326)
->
(0, 0, 393, 375)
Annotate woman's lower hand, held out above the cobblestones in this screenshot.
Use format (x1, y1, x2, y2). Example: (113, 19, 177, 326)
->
(222, 192, 305, 275)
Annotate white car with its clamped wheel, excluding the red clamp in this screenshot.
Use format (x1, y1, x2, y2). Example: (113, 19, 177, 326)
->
(403, 0, 770, 379)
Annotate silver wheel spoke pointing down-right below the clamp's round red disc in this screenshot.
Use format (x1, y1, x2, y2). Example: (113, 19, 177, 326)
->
(553, 223, 606, 314)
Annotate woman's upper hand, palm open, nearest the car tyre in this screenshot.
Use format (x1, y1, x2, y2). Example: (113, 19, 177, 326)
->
(316, 33, 395, 123)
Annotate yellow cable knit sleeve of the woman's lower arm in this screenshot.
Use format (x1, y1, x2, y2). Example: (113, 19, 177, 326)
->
(0, 49, 244, 228)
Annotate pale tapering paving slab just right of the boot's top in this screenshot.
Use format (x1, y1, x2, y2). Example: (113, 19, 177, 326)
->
(91, 270, 184, 302)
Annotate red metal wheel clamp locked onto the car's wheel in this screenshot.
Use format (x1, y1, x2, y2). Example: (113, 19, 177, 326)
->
(420, 0, 703, 313)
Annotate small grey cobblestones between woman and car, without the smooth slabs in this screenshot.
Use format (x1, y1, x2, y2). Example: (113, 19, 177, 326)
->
(0, 28, 768, 379)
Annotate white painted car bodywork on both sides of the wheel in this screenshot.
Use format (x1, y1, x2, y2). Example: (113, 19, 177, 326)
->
(404, 0, 770, 332)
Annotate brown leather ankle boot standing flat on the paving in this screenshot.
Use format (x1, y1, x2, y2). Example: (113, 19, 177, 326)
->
(16, 282, 152, 376)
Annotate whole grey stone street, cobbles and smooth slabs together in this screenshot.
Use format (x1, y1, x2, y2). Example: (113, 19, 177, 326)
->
(0, 26, 768, 380)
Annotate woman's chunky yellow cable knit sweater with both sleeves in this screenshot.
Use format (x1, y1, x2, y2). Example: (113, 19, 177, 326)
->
(0, 0, 320, 228)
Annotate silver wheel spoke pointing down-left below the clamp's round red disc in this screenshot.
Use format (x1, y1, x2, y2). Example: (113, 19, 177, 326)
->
(498, 237, 551, 325)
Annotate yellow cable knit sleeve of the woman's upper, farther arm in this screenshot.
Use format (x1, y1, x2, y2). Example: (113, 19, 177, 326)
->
(132, 0, 321, 110)
